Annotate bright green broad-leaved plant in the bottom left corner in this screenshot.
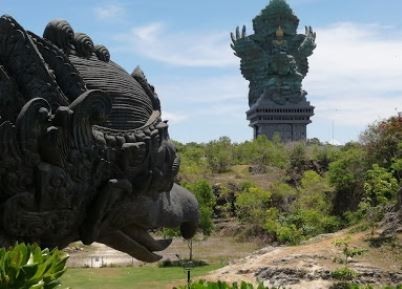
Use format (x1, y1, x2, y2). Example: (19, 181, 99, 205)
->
(0, 243, 68, 289)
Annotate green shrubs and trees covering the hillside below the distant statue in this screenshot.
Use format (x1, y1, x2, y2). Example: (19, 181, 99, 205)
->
(176, 117, 402, 244)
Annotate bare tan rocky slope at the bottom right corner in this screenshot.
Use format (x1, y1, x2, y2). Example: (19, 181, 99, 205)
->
(207, 231, 402, 289)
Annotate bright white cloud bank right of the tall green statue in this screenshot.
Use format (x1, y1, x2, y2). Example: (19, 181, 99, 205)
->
(303, 23, 402, 126)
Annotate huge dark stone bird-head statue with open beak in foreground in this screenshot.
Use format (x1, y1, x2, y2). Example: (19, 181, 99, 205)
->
(0, 16, 198, 262)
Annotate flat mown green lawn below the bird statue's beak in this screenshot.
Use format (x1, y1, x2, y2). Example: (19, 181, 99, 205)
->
(62, 264, 222, 289)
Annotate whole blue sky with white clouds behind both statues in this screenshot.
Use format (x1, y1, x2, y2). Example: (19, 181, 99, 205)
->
(0, 0, 402, 143)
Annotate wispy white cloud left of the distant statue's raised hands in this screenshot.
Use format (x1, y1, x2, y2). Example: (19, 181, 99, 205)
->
(116, 23, 238, 67)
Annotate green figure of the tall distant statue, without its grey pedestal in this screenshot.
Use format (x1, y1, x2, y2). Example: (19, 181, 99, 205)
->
(231, 0, 316, 107)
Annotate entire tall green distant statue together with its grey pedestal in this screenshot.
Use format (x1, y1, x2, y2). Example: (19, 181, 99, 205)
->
(231, 0, 316, 141)
